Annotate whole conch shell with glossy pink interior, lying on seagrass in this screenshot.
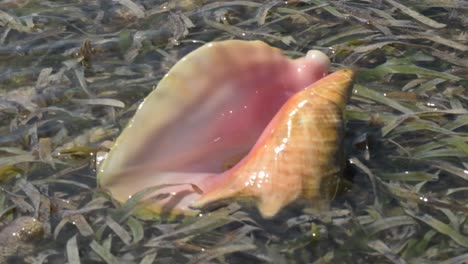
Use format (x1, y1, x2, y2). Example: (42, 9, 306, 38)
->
(97, 40, 353, 218)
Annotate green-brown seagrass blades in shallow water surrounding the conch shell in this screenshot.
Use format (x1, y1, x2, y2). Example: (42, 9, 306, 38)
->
(0, 0, 468, 264)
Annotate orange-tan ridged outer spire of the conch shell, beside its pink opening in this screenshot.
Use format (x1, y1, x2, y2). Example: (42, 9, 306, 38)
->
(192, 69, 354, 218)
